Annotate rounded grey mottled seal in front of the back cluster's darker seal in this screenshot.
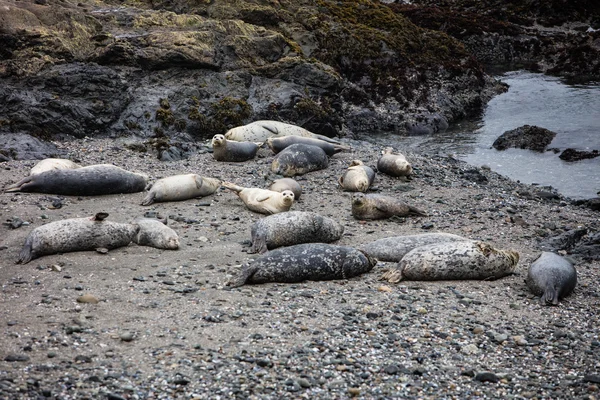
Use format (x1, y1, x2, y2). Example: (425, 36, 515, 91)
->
(271, 143, 329, 176)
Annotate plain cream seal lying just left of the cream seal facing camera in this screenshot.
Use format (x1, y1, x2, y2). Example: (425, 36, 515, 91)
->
(142, 174, 221, 206)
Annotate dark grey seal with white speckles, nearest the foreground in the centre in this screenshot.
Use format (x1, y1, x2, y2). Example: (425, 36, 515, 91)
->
(227, 243, 377, 287)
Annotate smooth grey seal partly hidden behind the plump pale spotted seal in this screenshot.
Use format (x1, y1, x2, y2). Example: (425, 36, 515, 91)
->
(359, 232, 470, 262)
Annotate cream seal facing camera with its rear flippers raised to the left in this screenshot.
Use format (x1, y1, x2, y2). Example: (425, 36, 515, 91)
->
(222, 182, 294, 214)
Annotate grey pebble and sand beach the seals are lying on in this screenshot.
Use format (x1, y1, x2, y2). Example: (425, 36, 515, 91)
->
(0, 139, 600, 399)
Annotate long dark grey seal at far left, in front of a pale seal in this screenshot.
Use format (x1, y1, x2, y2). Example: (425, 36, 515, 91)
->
(5, 164, 148, 196)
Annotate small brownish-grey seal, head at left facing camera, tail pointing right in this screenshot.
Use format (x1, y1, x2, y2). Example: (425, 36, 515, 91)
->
(352, 193, 427, 220)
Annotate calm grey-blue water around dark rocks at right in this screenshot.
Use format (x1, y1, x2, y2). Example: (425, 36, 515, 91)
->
(372, 71, 600, 199)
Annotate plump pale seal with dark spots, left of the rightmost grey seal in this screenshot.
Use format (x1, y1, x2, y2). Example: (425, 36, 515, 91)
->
(381, 241, 519, 283)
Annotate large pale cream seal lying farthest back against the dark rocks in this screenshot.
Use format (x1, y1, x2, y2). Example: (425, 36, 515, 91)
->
(225, 120, 340, 144)
